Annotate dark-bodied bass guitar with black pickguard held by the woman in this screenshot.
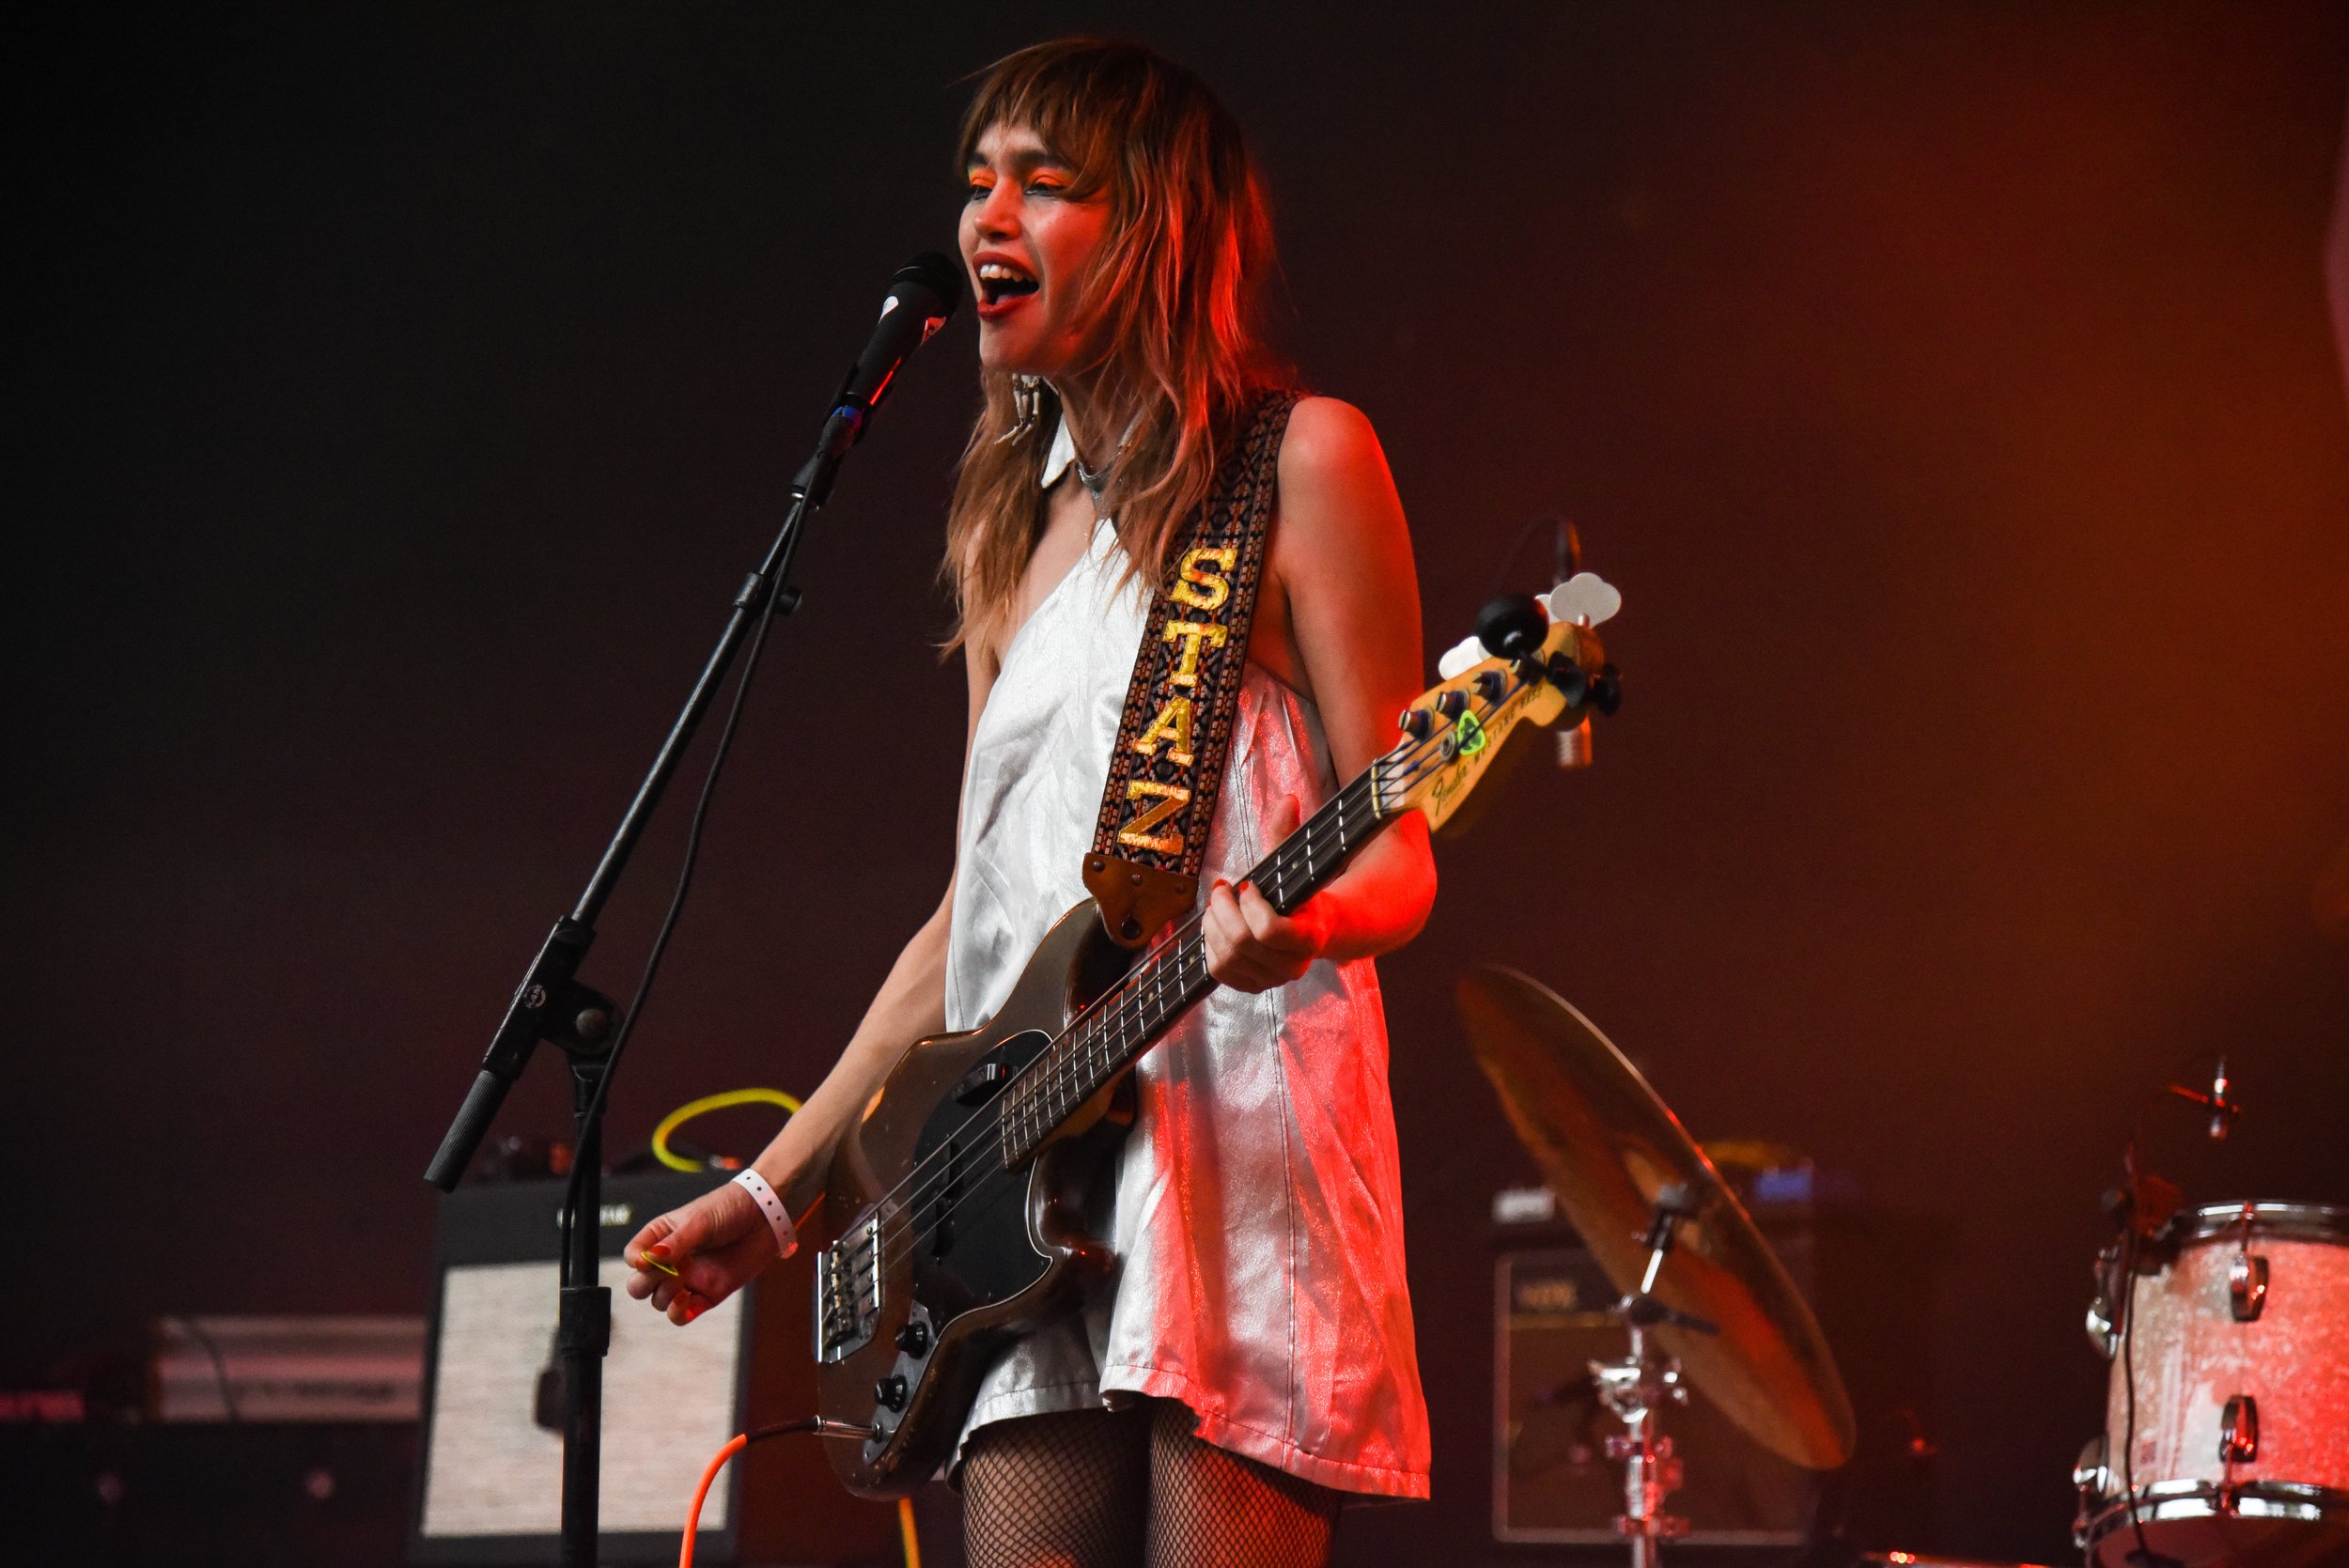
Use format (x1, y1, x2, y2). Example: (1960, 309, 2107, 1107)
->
(816, 575, 1621, 1498)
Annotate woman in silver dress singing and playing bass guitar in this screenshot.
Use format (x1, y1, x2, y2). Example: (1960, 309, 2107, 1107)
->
(630, 39, 1436, 1568)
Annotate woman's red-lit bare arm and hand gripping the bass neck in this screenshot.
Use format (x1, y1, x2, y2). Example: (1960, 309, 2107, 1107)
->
(1206, 396, 1436, 990)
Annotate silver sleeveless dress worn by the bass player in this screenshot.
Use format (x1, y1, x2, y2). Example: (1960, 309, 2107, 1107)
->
(947, 429, 1428, 1498)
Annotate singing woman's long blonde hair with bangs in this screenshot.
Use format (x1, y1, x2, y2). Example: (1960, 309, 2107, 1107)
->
(944, 38, 1290, 650)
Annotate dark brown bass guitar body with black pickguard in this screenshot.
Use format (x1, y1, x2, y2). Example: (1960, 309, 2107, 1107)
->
(816, 899, 1132, 1498)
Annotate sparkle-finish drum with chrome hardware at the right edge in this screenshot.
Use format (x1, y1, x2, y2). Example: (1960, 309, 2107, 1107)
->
(2075, 1204, 2349, 1568)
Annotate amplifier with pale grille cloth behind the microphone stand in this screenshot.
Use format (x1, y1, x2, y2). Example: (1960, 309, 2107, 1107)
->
(409, 1172, 897, 1563)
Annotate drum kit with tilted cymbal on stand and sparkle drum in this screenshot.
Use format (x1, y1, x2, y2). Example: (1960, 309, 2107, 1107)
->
(1459, 965, 2349, 1568)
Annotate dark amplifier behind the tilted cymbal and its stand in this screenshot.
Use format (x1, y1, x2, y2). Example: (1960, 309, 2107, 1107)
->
(1492, 1195, 1934, 1561)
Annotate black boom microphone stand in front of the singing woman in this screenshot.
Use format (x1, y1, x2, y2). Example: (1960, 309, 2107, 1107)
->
(426, 396, 872, 1568)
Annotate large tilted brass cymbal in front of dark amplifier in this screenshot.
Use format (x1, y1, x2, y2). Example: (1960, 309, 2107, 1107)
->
(1459, 965, 1854, 1469)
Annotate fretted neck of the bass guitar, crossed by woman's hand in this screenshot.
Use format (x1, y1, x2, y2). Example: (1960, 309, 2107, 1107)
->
(1003, 747, 1405, 1167)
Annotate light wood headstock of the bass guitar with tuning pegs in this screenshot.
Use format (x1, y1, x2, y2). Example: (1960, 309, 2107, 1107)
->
(1377, 573, 1624, 829)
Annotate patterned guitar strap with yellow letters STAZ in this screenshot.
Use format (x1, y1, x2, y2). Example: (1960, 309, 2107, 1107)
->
(1085, 392, 1301, 948)
